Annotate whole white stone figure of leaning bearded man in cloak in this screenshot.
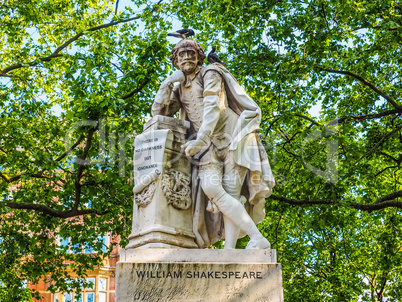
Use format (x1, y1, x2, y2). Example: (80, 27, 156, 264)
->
(152, 39, 275, 249)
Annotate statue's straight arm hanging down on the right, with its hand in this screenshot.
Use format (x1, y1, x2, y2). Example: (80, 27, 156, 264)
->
(185, 70, 222, 156)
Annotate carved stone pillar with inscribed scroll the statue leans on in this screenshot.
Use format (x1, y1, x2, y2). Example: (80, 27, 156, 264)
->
(126, 115, 198, 249)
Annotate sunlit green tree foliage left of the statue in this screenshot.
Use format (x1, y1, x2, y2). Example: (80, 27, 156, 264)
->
(0, 0, 170, 301)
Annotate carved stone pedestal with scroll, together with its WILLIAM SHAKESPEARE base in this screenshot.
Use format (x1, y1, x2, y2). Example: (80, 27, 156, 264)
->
(116, 116, 283, 302)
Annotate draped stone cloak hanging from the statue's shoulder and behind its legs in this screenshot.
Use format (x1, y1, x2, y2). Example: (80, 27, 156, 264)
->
(184, 63, 275, 248)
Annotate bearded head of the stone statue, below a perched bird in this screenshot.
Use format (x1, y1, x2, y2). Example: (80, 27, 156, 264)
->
(170, 39, 206, 74)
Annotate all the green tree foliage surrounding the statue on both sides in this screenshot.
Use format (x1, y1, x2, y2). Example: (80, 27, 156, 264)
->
(0, 0, 402, 301)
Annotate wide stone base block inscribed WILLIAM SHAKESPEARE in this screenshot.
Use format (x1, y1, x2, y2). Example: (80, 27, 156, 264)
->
(116, 248, 283, 302)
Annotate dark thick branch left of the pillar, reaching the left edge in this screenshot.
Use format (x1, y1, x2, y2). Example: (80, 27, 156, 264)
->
(3, 202, 110, 218)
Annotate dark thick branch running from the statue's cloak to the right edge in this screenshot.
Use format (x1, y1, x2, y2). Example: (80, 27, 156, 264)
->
(269, 191, 402, 212)
